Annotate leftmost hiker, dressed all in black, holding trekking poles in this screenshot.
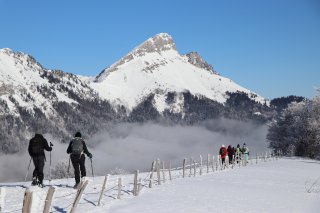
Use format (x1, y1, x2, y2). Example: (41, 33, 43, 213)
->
(28, 133, 52, 187)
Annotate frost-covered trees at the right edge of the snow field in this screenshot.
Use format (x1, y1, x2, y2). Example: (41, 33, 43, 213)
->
(267, 92, 320, 158)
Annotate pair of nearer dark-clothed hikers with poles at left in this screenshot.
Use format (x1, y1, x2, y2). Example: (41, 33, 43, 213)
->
(28, 132, 92, 189)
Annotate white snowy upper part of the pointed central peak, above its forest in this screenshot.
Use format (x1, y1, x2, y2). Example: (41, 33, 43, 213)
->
(91, 33, 265, 112)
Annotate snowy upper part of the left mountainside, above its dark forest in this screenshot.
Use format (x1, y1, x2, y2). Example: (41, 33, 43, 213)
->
(0, 48, 92, 117)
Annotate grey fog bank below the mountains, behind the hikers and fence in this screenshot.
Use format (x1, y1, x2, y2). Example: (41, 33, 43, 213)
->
(0, 120, 267, 182)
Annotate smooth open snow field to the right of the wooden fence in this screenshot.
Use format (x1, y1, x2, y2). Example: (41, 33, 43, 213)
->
(108, 159, 320, 213)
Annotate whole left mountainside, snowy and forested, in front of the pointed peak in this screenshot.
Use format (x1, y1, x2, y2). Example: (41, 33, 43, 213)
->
(0, 48, 114, 150)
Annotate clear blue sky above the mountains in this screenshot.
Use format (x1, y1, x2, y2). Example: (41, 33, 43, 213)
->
(0, 0, 320, 99)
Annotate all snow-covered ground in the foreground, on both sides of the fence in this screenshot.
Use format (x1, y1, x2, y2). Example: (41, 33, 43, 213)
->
(0, 158, 320, 213)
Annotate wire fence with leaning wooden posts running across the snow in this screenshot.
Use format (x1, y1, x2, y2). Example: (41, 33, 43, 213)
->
(0, 152, 281, 213)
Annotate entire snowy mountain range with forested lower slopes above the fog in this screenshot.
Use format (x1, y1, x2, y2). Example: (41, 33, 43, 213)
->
(0, 34, 273, 153)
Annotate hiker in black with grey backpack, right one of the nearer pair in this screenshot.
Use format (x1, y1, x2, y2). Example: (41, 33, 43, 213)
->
(67, 132, 92, 189)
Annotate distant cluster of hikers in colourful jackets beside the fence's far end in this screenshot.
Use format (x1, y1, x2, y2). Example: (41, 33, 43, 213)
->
(219, 143, 249, 165)
